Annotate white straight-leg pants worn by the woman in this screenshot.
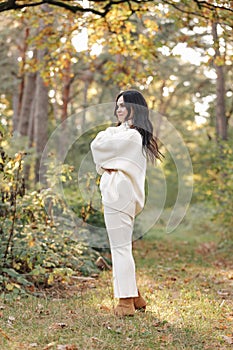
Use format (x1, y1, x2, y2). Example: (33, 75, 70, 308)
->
(104, 206, 138, 298)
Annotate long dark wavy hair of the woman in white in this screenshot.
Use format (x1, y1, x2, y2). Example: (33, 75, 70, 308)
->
(114, 90, 163, 163)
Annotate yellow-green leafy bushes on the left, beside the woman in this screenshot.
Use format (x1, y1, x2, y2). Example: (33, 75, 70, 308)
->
(0, 133, 98, 295)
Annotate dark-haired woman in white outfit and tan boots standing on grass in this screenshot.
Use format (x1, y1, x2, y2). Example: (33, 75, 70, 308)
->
(91, 90, 161, 316)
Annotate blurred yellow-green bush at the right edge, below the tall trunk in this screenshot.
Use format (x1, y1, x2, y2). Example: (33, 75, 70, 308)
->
(196, 135, 233, 236)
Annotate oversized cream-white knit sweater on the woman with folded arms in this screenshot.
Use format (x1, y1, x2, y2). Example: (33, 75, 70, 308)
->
(91, 123, 146, 217)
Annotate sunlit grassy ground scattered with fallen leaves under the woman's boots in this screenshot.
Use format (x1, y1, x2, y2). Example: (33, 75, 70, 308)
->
(0, 206, 233, 350)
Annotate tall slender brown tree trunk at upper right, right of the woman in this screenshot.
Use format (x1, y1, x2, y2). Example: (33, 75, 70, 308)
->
(212, 22, 227, 140)
